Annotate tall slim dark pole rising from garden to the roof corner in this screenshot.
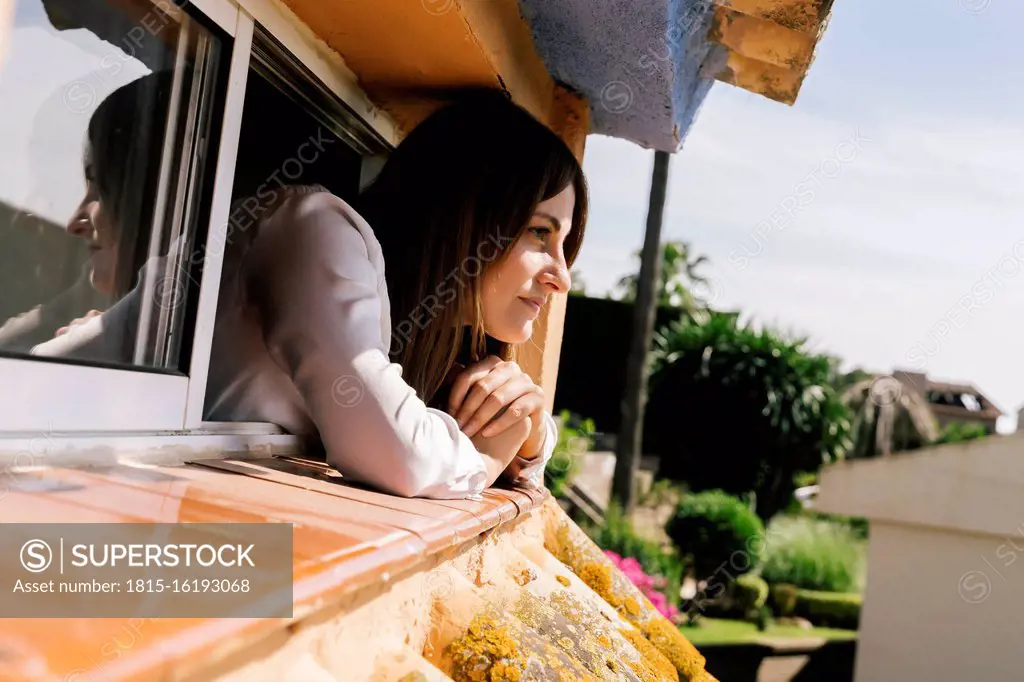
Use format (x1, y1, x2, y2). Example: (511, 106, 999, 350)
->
(611, 152, 671, 515)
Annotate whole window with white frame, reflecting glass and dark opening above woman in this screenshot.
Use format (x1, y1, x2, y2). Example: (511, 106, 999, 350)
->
(0, 0, 396, 442)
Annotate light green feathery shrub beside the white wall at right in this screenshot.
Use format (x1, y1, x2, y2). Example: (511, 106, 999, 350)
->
(761, 516, 864, 592)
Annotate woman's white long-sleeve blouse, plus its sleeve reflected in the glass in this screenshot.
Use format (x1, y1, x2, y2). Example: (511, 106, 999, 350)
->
(34, 187, 557, 499)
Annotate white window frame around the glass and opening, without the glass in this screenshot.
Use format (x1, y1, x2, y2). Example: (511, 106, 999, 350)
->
(0, 0, 399, 440)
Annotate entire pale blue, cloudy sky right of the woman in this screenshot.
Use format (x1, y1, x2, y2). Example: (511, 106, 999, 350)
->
(573, 0, 1024, 432)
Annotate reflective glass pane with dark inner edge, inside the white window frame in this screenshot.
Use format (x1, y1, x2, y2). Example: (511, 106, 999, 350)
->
(0, 0, 222, 372)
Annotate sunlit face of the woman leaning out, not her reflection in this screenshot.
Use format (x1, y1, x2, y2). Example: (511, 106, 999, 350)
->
(482, 185, 575, 343)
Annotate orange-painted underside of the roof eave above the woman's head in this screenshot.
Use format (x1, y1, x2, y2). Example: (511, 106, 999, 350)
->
(284, 0, 555, 132)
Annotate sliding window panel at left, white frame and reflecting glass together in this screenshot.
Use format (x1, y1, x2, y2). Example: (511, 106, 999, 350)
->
(0, 0, 231, 435)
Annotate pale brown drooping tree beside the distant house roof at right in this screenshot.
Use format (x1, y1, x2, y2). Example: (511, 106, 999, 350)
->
(843, 375, 940, 458)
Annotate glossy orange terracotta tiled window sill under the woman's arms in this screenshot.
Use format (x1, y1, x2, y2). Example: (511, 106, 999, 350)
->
(0, 450, 548, 682)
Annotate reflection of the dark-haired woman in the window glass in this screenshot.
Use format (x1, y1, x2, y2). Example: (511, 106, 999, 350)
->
(0, 74, 170, 352)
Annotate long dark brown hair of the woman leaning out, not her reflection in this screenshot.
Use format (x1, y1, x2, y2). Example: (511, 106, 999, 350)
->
(356, 90, 588, 403)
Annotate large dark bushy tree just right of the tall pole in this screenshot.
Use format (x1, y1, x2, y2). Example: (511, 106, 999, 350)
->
(645, 312, 850, 521)
